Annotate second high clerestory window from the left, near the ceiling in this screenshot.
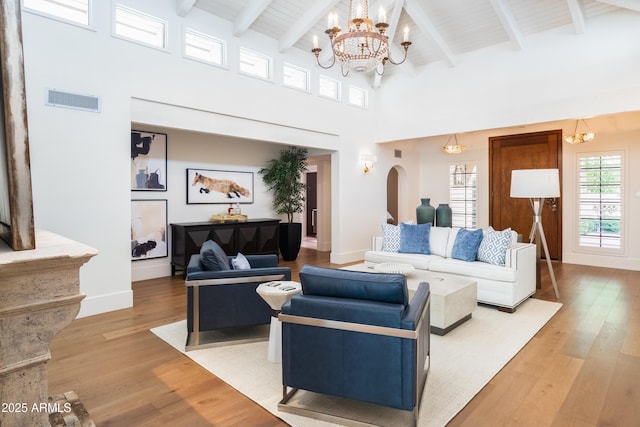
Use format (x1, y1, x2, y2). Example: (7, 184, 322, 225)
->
(114, 4, 167, 49)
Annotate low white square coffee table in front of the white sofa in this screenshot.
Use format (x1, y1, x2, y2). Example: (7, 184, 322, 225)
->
(344, 264, 478, 335)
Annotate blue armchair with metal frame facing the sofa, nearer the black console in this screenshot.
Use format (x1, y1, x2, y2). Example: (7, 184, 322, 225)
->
(185, 254, 291, 350)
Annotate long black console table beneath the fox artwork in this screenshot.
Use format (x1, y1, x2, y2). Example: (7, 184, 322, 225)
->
(171, 219, 280, 275)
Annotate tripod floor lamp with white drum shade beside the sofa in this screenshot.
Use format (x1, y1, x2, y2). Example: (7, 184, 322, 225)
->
(511, 169, 560, 298)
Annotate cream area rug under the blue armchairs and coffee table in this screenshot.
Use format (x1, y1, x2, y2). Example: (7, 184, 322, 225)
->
(151, 299, 562, 427)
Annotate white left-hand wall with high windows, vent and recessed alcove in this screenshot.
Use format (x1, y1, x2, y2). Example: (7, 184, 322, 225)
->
(22, 0, 375, 316)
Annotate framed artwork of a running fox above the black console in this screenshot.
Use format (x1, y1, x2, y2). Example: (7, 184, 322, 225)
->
(187, 169, 253, 205)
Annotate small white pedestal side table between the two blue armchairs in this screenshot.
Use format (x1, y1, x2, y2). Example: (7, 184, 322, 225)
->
(256, 280, 302, 363)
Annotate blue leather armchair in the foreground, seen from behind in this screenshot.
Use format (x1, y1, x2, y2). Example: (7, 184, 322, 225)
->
(279, 266, 430, 422)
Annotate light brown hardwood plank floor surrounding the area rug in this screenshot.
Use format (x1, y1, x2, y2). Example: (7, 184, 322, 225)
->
(49, 248, 640, 427)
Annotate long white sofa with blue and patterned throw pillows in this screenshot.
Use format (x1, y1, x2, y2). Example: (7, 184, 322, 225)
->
(364, 227, 536, 311)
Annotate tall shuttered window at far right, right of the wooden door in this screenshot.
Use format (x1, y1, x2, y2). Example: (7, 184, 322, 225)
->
(578, 153, 622, 252)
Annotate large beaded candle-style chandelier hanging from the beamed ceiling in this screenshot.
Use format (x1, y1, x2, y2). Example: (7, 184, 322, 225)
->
(311, 0, 411, 77)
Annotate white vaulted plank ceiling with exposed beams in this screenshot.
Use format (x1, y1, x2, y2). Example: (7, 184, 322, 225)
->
(186, 0, 640, 72)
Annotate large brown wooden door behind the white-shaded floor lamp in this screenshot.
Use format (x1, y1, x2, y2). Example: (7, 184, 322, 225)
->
(489, 130, 562, 260)
